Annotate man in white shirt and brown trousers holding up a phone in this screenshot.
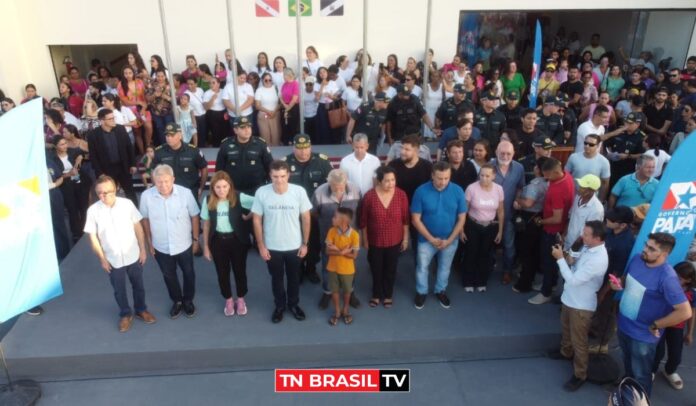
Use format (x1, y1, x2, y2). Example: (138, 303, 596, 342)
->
(549, 221, 609, 392)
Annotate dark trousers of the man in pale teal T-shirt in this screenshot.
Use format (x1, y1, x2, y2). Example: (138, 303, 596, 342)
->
(266, 247, 300, 309)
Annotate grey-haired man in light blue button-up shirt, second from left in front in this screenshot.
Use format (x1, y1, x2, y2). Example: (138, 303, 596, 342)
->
(140, 164, 200, 319)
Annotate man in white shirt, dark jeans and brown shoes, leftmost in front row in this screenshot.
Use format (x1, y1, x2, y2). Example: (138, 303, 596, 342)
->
(84, 175, 155, 333)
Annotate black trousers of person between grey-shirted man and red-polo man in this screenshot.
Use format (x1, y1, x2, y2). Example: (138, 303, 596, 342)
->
(515, 212, 550, 292)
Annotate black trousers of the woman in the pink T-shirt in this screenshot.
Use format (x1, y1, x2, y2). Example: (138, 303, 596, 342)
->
(462, 218, 498, 287)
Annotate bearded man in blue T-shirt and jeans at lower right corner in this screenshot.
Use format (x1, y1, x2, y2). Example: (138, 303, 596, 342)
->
(611, 233, 691, 394)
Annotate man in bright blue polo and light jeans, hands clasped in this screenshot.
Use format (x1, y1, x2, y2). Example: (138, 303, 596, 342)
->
(411, 162, 467, 309)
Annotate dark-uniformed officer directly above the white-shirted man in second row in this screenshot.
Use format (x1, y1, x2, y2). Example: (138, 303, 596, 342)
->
(346, 92, 389, 155)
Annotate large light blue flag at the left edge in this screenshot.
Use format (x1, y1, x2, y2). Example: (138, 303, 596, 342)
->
(0, 98, 63, 323)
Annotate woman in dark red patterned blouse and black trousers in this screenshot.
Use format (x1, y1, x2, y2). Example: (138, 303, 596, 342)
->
(360, 166, 409, 308)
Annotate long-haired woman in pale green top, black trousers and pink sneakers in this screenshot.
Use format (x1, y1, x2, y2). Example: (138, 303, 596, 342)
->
(201, 171, 254, 316)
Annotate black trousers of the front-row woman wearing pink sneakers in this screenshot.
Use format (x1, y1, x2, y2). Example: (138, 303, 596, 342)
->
(210, 233, 249, 299)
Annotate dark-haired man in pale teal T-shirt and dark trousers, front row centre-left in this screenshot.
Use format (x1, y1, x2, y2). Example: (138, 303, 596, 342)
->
(251, 161, 312, 323)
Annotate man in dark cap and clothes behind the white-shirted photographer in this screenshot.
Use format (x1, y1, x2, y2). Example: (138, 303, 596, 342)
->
(590, 206, 636, 354)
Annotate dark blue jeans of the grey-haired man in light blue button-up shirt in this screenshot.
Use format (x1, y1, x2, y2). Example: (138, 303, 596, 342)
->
(155, 247, 196, 303)
